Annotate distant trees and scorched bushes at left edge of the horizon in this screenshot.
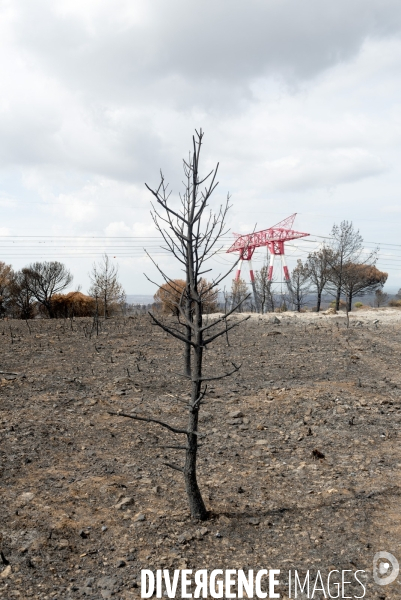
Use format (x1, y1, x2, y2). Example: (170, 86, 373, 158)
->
(0, 254, 125, 319)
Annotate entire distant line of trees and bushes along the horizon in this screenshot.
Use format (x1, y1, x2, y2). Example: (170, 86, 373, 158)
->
(0, 221, 394, 319)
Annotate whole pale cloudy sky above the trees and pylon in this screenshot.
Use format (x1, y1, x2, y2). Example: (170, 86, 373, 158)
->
(0, 0, 401, 294)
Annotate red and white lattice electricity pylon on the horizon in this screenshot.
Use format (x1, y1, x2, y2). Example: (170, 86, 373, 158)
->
(227, 213, 309, 306)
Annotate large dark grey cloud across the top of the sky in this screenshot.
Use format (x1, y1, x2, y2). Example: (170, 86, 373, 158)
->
(16, 0, 401, 106)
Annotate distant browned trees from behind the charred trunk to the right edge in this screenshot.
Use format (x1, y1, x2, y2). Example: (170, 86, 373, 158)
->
(148, 221, 390, 315)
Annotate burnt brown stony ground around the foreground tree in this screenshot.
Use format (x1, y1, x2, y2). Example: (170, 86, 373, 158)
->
(0, 312, 401, 600)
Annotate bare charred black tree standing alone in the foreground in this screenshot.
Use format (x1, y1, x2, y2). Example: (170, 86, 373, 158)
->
(111, 130, 245, 520)
